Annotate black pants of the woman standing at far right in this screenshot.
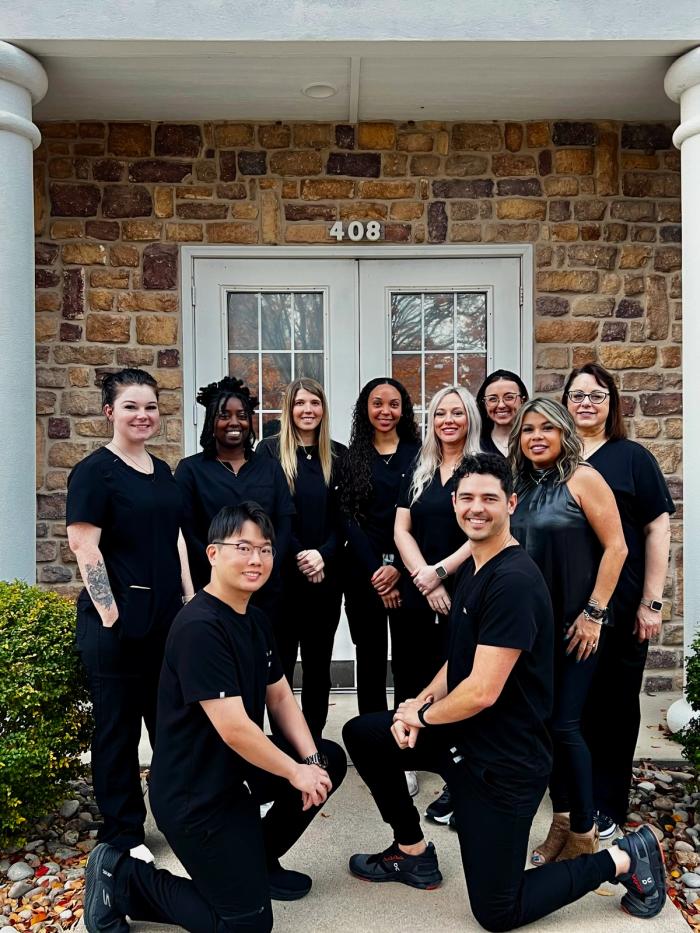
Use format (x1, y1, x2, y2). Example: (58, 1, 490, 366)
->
(583, 603, 649, 825)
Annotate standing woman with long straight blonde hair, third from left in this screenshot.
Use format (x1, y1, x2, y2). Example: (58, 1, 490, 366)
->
(255, 378, 346, 738)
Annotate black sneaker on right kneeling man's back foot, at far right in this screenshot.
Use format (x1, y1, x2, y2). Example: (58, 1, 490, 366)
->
(613, 826, 666, 919)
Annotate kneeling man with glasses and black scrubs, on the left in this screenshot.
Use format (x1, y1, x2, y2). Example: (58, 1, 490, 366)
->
(85, 502, 346, 933)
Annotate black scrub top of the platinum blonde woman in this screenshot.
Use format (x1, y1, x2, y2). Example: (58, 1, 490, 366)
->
(398, 469, 467, 609)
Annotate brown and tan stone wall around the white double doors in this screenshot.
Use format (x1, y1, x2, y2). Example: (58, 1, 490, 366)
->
(35, 122, 682, 689)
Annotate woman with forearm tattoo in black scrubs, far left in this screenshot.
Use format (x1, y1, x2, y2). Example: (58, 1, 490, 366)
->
(66, 369, 193, 861)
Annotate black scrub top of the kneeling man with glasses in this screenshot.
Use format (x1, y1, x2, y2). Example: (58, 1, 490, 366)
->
(150, 590, 283, 824)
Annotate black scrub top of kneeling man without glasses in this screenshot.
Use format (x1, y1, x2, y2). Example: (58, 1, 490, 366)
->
(447, 546, 554, 779)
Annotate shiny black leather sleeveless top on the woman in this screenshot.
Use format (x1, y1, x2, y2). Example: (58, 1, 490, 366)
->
(510, 468, 603, 631)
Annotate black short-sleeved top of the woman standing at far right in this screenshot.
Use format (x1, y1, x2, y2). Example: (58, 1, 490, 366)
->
(588, 438, 676, 625)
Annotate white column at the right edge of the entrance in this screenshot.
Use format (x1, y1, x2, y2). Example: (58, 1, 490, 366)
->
(664, 48, 700, 731)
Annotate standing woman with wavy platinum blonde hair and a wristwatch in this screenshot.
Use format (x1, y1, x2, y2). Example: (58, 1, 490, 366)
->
(392, 385, 481, 796)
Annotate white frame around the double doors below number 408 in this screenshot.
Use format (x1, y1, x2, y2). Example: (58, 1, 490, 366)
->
(180, 243, 534, 449)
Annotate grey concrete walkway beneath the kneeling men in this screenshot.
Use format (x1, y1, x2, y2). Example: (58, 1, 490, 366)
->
(79, 695, 688, 933)
